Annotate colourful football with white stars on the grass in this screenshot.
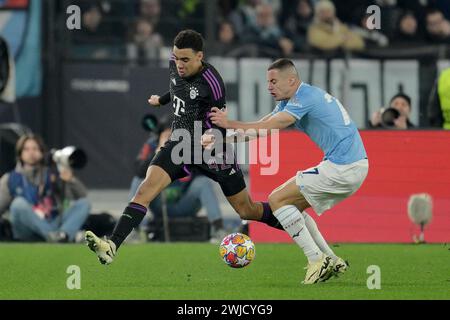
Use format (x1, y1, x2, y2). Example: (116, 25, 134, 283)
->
(219, 233, 256, 268)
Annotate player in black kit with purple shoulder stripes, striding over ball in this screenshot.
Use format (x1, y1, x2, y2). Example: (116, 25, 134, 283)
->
(86, 30, 283, 264)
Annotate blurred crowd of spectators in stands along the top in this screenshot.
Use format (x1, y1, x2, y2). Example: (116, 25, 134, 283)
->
(70, 0, 450, 62)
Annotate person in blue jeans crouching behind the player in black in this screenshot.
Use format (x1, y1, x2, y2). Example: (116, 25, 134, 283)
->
(130, 118, 226, 242)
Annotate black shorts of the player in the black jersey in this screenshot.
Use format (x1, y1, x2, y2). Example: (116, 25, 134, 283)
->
(150, 140, 245, 197)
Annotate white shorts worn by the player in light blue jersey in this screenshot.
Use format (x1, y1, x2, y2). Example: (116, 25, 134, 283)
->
(295, 159, 369, 215)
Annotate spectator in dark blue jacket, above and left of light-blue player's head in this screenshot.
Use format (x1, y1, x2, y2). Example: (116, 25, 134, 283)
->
(243, 4, 294, 56)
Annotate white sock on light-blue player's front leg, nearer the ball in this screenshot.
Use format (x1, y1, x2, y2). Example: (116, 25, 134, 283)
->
(273, 205, 322, 263)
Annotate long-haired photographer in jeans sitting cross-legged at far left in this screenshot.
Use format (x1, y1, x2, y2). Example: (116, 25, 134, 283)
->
(0, 134, 90, 242)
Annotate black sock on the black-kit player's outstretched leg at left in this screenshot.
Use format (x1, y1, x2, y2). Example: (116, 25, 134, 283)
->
(110, 202, 147, 250)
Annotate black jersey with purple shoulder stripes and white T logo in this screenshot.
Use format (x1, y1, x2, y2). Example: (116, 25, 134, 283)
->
(169, 57, 226, 143)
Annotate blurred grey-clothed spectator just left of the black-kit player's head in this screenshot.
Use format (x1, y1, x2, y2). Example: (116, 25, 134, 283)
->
(127, 18, 163, 63)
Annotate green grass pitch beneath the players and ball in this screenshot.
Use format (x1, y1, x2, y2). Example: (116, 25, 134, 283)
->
(0, 243, 450, 300)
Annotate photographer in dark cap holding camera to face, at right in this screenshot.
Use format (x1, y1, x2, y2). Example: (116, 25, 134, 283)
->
(370, 93, 414, 130)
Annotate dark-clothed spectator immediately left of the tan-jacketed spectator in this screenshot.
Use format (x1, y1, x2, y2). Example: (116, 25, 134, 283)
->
(284, 0, 313, 52)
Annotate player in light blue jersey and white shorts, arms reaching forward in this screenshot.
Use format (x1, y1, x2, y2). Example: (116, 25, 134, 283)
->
(206, 59, 369, 284)
